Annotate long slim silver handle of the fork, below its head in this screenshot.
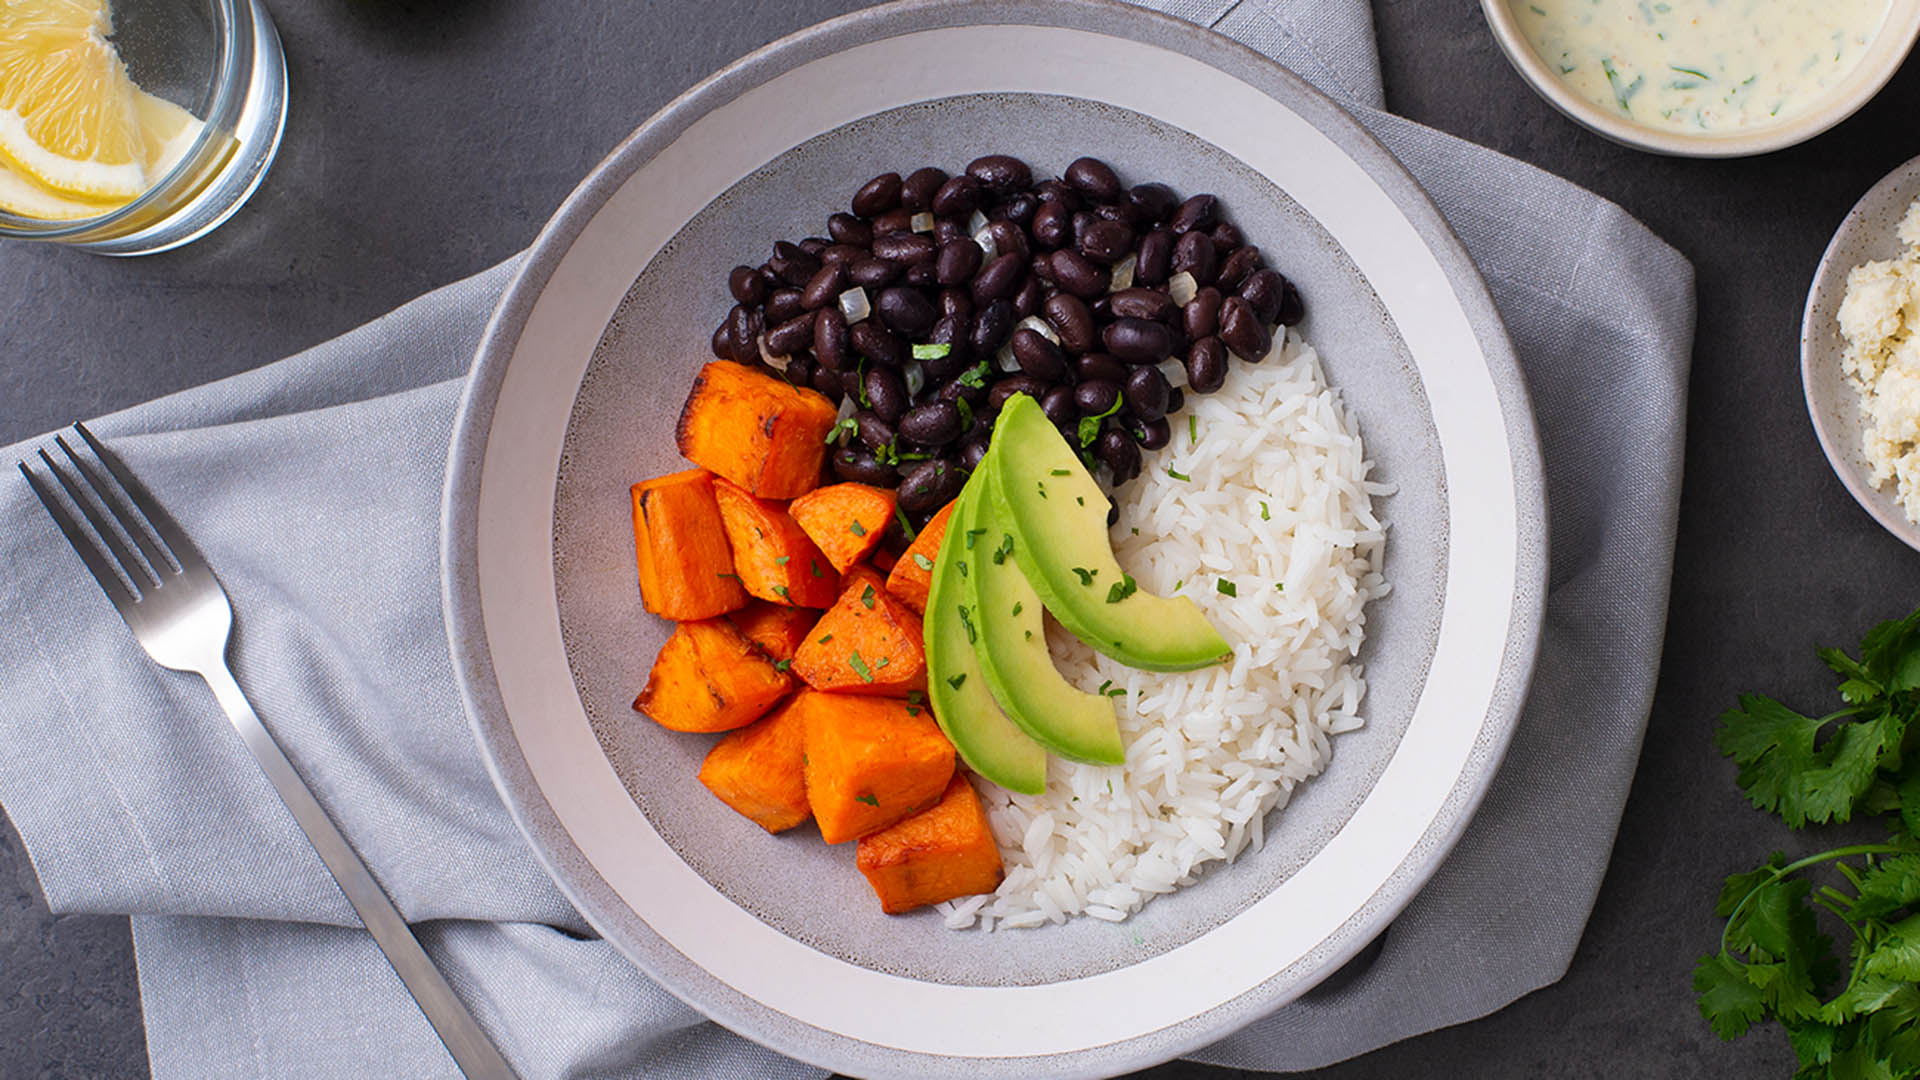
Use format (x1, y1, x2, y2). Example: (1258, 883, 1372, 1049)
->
(200, 663, 516, 1080)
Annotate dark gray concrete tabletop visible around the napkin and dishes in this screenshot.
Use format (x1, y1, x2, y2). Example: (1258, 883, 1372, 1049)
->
(0, 0, 1920, 1080)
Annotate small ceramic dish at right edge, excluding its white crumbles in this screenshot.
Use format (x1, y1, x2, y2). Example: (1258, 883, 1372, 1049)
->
(1801, 158, 1920, 550)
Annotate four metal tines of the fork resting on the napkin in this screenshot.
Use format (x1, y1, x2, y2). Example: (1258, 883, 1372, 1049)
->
(19, 425, 192, 603)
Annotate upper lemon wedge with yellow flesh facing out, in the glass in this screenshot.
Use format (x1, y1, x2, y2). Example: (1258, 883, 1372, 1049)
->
(0, 0, 148, 202)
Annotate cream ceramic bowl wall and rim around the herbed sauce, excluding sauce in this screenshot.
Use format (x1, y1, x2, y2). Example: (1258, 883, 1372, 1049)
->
(1480, 0, 1920, 158)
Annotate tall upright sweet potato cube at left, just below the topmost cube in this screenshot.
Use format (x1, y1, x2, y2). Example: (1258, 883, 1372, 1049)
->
(634, 469, 747, 621)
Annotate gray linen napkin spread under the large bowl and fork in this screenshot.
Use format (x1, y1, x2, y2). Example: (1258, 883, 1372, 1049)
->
(0, 0, 1693, 1080)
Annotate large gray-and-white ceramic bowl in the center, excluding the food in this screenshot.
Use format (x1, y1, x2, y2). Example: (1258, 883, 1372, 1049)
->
(444, 0, 1546, 1078)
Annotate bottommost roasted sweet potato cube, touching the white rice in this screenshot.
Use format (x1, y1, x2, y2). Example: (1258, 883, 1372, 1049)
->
(856, 773, 1006, 915)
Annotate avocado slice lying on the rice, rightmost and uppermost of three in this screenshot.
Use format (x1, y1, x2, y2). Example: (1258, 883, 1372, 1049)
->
(989, 394, 1231, 671)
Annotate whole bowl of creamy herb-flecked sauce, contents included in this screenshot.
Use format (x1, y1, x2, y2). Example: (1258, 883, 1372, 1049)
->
(1480, 0, 1920, 158)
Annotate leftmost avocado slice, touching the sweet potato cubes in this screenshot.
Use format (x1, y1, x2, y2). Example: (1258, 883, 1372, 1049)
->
(925, 470, 1046, 796)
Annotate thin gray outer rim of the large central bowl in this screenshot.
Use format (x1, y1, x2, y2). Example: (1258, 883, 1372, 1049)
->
(442, 0, 1548, 1076)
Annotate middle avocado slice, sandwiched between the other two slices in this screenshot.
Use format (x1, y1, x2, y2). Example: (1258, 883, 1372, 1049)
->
(966, 440, 1127, 765)
